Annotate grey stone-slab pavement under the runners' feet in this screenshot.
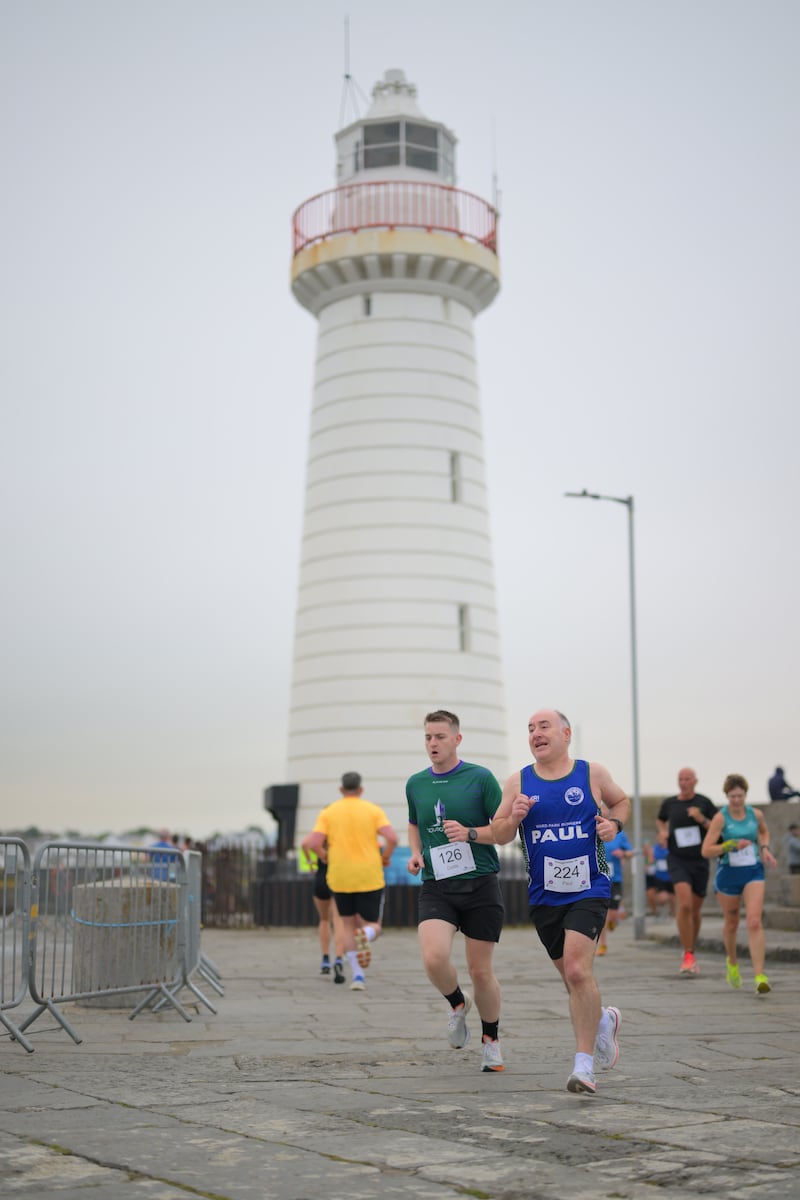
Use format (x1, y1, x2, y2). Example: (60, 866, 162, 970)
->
(0, 918, 800, 1200)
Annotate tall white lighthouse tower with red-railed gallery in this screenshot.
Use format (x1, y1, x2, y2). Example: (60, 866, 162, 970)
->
(288, 71, 507, 839)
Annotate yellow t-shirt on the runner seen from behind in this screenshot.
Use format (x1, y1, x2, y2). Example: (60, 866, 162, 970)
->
(314, 796, 390, 892)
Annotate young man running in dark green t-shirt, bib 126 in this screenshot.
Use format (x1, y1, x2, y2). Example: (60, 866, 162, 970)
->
(405, 709, 505, 1070)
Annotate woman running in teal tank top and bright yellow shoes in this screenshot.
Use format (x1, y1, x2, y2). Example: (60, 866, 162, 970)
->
(702, 775, 777, 995)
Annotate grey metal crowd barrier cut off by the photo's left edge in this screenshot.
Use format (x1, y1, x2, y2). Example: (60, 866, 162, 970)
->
(0, 838, 34, 1054)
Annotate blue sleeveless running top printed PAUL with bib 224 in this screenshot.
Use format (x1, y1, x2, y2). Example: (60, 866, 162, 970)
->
(519, 758, 610, 905)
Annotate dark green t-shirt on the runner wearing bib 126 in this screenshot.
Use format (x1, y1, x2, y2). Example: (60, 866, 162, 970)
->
(405, 762, 503, 880)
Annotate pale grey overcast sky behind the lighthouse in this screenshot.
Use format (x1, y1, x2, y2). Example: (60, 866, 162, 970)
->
(0, 0, 800, 836)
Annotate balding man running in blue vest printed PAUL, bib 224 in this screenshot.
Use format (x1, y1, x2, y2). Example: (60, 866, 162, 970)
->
(492, 708, 631, 1096)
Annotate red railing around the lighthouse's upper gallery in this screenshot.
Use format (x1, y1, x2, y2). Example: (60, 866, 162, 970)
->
(291, 180, 498, 254)
